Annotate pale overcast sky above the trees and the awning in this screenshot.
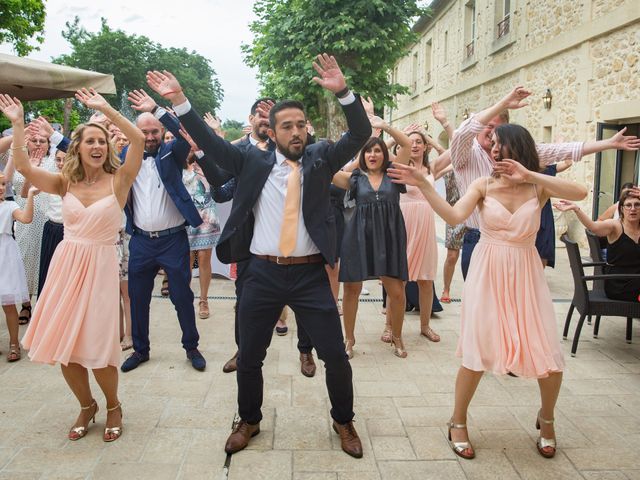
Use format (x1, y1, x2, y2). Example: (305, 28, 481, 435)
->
(0, 0, 259, 122)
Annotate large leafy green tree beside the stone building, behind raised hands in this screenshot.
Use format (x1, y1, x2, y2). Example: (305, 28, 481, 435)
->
(242, 0, 426, 138)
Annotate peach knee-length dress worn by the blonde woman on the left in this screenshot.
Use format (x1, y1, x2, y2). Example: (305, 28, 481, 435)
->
(22, 178, 122, 369)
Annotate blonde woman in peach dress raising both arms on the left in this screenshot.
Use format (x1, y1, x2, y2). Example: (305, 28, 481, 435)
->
(0, 89, 144, 442)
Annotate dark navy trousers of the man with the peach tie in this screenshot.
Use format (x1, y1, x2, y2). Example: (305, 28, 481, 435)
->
(236, 257, 353, 424)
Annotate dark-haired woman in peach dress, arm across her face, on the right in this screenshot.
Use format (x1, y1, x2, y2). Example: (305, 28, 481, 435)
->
(389, 124, 587, 459)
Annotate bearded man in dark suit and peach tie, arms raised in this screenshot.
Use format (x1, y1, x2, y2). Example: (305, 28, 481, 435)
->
(147, 54, 371, 458)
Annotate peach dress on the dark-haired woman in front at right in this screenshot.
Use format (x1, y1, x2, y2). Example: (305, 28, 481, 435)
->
(457, 183, 564, 378)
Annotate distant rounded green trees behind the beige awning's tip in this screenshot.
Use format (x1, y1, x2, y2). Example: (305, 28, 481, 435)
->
(54, 17, 223, 117)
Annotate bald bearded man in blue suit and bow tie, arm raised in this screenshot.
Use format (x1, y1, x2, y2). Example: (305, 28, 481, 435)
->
(120, 90, 206, 372)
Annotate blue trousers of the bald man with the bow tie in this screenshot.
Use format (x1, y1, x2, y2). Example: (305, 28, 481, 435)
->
(129, 230, 200, 355)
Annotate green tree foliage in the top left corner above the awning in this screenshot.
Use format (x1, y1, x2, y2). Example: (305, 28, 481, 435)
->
(0, 0, 45, 56)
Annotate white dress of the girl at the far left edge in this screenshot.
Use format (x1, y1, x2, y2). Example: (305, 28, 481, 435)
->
(0, 201, 29, 305)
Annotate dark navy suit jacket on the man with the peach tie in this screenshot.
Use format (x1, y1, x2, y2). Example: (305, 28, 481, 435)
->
(180, 98, 371, 266)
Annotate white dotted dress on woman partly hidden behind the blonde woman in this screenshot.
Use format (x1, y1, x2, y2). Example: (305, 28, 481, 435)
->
(13, 156, 57, 294)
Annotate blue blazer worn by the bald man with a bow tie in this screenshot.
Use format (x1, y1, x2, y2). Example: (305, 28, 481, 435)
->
(120, 112, 202, 235)
